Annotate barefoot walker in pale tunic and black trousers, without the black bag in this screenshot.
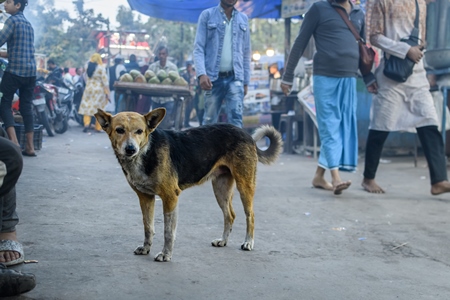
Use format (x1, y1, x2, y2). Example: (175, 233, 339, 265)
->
(362, 0, 450, 195)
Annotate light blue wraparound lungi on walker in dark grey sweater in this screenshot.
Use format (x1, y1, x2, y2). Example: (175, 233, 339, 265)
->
(313, 75, 358, 172)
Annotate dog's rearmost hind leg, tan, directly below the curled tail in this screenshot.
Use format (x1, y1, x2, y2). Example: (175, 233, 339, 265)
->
(236, 173, 256, 251)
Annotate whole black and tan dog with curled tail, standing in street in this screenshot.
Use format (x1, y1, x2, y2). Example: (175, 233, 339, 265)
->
(95, 108, 283, 261)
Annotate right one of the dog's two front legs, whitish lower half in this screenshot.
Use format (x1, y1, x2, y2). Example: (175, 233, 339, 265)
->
(155, 197, 178, 261)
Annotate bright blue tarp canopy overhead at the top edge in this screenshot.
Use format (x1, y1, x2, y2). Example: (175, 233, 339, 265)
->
(128, 0, 281, 23)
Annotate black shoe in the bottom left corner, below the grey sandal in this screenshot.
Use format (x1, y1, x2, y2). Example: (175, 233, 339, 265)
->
(0, 264, 36, 298)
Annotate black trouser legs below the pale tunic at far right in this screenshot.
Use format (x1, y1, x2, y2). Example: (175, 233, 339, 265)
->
(364, 126, 447, 184)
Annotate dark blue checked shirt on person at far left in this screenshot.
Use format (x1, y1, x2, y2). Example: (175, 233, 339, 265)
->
(0, 11, 36, 77)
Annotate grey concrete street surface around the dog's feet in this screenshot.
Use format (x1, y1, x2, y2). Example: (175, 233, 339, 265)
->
(5, 124, 450, 300)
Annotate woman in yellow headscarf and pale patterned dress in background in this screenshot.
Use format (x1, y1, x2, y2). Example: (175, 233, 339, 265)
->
(78, 53, 109, 132)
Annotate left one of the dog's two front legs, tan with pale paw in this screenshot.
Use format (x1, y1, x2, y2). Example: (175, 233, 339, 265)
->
(134, 192, 155, 255)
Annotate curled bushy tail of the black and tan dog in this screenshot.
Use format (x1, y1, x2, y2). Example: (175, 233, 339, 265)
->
(252, 125, 283, 165)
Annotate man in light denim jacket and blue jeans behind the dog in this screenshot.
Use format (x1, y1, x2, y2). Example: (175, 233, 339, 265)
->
(193, 0, 251, 127)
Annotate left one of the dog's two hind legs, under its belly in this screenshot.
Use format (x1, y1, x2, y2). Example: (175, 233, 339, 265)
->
(211, 173, 236, 247)
